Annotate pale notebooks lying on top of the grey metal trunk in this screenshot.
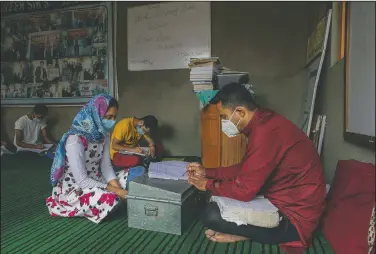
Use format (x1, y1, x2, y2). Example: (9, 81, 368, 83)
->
(148, 161, 189, 181)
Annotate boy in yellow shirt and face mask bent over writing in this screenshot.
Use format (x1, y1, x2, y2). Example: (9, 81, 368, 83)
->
(110, 115, 162, 169)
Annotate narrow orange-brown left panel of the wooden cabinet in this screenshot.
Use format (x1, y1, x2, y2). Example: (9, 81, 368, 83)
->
(201, 105, 222, 168)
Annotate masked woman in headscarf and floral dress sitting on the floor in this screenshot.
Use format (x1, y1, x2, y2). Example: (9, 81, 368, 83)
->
(46, 94, 128, 223)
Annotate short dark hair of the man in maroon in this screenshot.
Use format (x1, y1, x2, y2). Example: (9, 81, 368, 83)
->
(210, 83, 260, 111)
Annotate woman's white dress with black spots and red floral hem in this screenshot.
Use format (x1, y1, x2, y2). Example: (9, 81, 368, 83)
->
(46, 136, 128, 223)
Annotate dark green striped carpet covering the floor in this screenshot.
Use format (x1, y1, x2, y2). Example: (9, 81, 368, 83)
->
(1, 155, 333, 254)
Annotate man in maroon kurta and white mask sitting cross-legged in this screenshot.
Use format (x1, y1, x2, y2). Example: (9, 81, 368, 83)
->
(187, 84, 326, 253)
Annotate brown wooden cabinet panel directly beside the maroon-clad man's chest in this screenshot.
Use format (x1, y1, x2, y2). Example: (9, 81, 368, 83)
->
(221, 131, 248, 167)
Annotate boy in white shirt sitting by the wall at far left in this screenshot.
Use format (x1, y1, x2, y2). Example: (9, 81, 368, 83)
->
(14, 104, 55, 151)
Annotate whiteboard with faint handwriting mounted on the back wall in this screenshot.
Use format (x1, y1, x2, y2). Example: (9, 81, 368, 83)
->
(127, 2, 211, 71)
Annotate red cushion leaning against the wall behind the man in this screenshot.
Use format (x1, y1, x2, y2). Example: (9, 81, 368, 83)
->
(323, 160, 375, 254)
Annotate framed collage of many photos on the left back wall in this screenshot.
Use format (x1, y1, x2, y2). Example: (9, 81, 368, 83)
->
(1, 6, 108, 100)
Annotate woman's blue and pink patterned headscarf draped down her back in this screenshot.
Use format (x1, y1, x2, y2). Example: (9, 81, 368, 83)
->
(51, 94, 113, 185)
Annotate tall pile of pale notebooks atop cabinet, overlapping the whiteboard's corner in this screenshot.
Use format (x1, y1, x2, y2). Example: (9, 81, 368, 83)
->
(189, 57, 222, 92)
